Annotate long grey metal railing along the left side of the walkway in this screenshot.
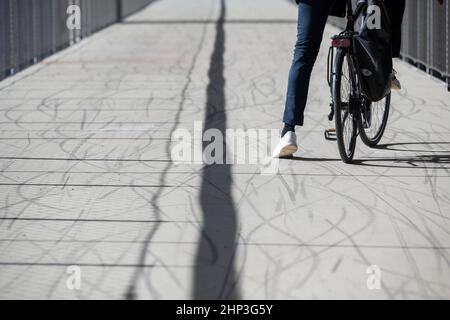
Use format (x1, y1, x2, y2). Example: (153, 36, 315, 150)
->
(0, 0, 154, 80)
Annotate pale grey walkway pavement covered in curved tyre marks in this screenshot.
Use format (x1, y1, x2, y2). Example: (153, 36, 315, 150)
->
(0, 0, 450, 299)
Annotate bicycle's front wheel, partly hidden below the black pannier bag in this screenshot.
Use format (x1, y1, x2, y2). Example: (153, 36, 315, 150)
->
(359, 94, 391, 148)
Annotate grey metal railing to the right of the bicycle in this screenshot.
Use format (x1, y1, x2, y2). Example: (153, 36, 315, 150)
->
(329, 0, 450, 91)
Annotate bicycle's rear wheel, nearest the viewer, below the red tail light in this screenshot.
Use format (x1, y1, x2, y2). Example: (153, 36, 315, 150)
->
(332, 49, 358, 163)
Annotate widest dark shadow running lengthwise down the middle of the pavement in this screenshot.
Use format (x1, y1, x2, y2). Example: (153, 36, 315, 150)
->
(193, 0, 240, 299)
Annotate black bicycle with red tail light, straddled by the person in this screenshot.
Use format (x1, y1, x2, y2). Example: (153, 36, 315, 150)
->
(325, 0, 391, 163)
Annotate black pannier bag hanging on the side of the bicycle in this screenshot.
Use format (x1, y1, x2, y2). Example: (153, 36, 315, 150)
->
(353, 0, 392, 102)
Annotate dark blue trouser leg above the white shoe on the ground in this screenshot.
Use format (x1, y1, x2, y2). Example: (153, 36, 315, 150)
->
(283, 0, 334, 126)
